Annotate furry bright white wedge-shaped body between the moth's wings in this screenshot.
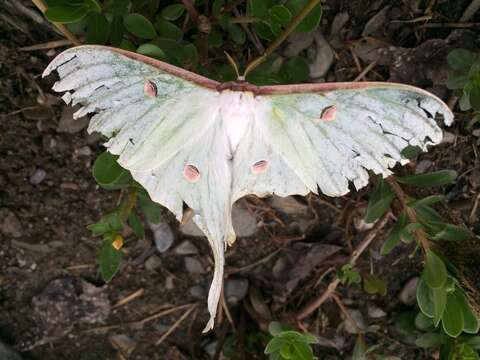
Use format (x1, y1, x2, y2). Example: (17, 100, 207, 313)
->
(220, 90, 255, 156)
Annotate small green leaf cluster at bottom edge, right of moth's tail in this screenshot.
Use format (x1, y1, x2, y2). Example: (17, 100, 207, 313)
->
(265, 322, 318, 360)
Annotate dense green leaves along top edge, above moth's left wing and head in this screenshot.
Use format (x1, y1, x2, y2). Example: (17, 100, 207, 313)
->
(45, 0, 322, 85)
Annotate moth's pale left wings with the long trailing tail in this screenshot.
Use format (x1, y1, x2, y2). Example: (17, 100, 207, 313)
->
(44, 46, 229, 329)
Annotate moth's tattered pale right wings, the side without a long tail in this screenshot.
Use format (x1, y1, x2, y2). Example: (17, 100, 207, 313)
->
(233, 83, 453, 199)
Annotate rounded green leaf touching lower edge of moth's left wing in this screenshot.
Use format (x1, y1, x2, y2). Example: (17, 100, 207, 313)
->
(92, 152, 131, 190)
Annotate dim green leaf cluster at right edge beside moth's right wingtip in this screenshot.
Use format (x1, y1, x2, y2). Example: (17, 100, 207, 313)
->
(447, 49, 480, 111)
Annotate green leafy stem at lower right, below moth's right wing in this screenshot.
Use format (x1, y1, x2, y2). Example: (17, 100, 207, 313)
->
(366, 170, 479, 348)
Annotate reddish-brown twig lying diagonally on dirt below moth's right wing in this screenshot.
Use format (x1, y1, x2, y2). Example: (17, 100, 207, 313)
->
(295, 212, 391, 321)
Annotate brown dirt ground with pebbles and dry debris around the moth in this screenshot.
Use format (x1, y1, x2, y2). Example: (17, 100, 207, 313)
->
(0, 0, 480, 360)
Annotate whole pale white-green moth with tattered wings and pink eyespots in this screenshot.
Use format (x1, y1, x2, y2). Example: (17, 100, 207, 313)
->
(43, 46, 453, 331)
